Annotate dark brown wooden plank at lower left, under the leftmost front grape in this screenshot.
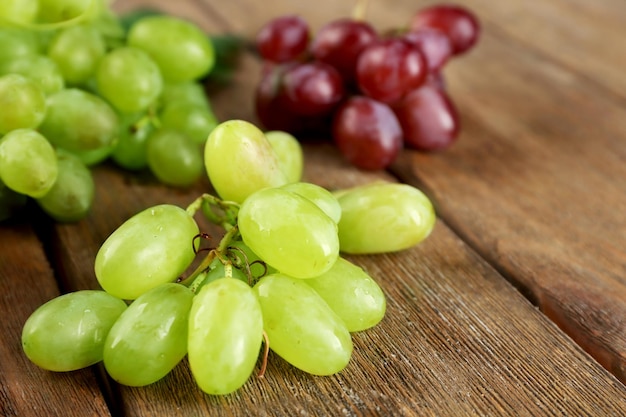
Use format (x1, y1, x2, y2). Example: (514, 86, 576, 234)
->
(0, 221, 109, 417)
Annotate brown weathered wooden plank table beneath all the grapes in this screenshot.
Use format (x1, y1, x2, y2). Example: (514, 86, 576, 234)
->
(0, 0, 626, 417)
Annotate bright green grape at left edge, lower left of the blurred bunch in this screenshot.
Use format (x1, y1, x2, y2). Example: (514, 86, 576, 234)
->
(0, 129, 58, 198)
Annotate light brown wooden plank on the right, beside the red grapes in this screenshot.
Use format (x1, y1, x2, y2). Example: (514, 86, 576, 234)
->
(388, 4, 626, 381)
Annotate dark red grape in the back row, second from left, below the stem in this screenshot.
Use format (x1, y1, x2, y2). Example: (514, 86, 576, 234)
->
(311, 19, 378, 82)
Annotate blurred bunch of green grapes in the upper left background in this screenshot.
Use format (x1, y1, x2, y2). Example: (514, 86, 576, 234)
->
(0, 0, 217, 221)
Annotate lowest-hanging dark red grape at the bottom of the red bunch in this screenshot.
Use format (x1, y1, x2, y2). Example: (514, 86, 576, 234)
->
(332, 96, 402, 170)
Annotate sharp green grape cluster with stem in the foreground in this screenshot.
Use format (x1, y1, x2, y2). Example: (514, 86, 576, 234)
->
(22, 120, 435, 395)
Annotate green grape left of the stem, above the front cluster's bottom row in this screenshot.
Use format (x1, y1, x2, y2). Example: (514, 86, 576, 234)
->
(95, 204, 198, 300)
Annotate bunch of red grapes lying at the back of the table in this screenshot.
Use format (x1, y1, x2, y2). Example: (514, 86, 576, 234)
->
(255, 4, 480, 170)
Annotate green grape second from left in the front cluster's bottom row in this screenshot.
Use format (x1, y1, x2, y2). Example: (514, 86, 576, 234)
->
(104, 283, 193, 387)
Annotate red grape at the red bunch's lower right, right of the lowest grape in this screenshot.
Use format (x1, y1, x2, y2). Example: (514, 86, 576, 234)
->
(394, 83, 459, 151)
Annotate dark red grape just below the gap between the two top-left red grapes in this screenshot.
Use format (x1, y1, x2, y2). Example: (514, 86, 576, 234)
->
(283, 61, 344, 116)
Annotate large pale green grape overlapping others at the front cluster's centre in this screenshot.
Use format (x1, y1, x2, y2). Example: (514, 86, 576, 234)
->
(237, 188, 339, 278)
